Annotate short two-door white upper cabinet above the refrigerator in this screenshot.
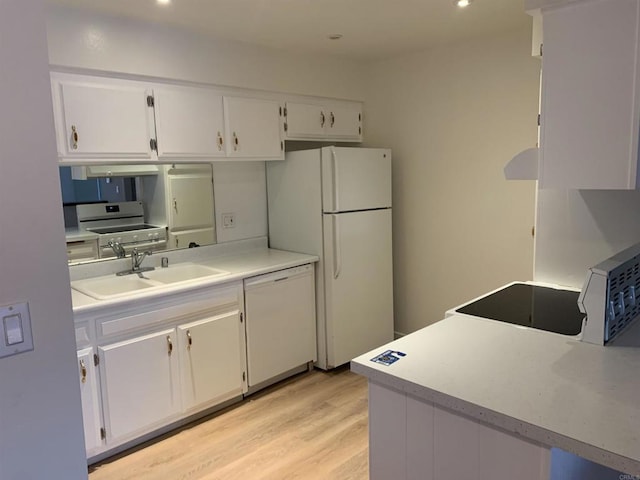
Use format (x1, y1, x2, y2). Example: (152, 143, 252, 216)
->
(285, 101, 362, 142)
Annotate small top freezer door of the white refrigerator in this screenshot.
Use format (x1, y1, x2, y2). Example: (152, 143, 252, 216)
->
(322, 147, 391, 213)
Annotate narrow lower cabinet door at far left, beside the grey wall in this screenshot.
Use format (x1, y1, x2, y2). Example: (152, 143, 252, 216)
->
(78, 348, 102, 458)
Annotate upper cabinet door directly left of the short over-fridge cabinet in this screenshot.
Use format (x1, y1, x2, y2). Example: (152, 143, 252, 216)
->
(224, 97, 284, 160)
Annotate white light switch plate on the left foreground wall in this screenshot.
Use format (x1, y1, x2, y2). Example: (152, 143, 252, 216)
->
(0, 303, 33, 358)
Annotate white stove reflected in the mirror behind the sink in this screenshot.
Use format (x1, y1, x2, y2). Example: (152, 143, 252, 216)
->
(76, 202, 167, 258)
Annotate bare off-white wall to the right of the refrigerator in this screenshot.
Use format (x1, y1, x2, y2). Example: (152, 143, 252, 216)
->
(364, 29, 540, 333)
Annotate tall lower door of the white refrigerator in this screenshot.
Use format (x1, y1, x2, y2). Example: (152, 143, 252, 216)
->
(323, 209, 393, 367)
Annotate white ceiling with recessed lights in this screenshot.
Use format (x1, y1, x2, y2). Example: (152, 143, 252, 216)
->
(48, 0, 530, 60)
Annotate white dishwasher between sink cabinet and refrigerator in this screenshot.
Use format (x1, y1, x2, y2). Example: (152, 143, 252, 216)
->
(244, 264, 317, 389)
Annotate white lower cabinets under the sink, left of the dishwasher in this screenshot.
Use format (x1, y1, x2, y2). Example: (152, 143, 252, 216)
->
(75, 281, 247, 461)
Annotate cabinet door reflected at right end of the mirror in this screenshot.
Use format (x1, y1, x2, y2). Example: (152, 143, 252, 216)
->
(167, 171, 214, 231)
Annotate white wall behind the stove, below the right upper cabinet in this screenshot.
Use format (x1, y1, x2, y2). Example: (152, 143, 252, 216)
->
(534, 189, 640, 288)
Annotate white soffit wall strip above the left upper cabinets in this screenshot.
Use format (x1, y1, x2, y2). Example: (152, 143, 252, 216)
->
(47, 7, 365, 100)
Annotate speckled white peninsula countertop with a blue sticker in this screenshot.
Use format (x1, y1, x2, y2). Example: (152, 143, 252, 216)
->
(351, 315, 640, 475)
